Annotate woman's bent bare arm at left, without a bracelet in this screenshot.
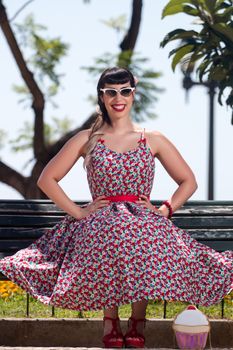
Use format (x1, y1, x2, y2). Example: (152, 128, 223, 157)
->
(37, 130, 88, 219)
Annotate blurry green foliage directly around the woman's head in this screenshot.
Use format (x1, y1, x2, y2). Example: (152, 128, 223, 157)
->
(83, 51, 163, 122)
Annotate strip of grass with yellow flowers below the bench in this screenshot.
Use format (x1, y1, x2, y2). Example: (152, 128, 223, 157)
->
(0, 282, 233, 319)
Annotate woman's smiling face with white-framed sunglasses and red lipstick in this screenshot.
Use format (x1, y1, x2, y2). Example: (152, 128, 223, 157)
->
(101, 82, 135, 119)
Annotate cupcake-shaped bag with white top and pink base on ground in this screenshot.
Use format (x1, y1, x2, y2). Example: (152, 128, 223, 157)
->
(172, 305, 210, 350)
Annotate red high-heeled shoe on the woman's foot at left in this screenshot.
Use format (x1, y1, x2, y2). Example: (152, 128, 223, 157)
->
(102, 316, 124, 348)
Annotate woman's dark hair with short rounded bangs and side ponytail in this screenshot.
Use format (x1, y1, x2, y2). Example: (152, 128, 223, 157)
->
(97, 67, 136, 125)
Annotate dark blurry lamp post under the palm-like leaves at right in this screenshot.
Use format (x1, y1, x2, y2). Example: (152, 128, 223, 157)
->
(183, 74, 217, 200)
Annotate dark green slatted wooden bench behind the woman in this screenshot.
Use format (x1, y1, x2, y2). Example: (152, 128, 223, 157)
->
(0, 200, 233, 318)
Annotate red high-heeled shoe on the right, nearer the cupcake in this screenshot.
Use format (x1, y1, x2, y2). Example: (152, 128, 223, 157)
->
(124, 317, 146, 348)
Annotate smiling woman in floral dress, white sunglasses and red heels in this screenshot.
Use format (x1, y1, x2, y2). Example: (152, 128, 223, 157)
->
(0, 67, 233, 348)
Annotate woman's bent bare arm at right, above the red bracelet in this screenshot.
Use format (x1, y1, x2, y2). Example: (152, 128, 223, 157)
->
(150, 132, 197, 216)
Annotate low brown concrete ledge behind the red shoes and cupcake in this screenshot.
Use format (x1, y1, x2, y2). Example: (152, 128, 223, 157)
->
(0, 318, 233, 349)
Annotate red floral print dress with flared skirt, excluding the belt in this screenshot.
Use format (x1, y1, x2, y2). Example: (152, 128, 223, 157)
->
(0, 133, 233, 311)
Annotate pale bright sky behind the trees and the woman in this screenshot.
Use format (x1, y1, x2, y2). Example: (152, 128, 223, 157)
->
(0, 0, 233, 200)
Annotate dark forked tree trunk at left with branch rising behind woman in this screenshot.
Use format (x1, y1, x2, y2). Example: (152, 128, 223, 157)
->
(0, 0, 142, 199)
